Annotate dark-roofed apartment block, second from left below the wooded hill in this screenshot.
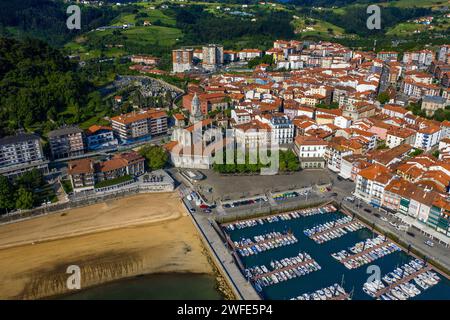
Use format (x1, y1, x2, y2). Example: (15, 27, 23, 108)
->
(48, 127, 85, 159)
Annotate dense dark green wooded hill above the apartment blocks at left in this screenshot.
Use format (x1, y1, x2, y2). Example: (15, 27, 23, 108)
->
(0, 38, 103, 135)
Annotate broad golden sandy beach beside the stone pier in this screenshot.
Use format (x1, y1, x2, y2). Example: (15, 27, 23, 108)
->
(0, 193, 213, 299)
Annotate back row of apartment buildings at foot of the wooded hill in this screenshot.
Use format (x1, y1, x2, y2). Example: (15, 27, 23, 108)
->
(0, 110, 168, 178)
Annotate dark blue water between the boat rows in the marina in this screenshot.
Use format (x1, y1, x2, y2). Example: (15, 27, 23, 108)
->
(225, 212, 450, 300)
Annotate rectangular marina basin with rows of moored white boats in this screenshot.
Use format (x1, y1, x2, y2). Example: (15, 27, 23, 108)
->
(221, 205, 450, 300)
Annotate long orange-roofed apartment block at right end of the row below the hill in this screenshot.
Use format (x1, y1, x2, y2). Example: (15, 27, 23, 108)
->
(111, 109, 167, 144)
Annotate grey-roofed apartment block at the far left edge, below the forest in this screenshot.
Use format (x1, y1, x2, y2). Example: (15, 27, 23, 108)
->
(0, 133, 48, 178)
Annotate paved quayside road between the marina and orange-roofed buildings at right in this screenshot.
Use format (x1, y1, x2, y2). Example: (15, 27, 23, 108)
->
(330, 173, 450, 270)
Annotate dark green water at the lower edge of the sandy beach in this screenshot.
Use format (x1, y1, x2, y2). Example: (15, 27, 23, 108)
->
(60, 273, 223, 300)
